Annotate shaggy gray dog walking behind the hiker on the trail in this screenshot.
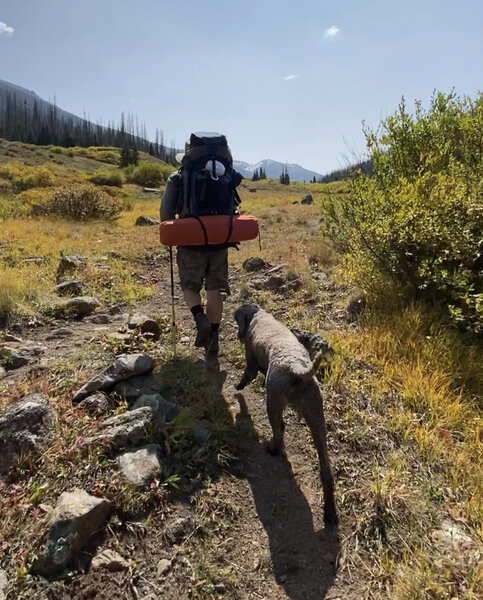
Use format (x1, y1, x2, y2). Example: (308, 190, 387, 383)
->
(235, 304, 337, 524)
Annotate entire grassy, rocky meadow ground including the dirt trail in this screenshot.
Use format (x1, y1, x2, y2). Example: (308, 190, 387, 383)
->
(0, 140, 483, 600)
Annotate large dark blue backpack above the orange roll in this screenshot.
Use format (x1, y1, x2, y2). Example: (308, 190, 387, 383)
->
(179, 133, 242, 217)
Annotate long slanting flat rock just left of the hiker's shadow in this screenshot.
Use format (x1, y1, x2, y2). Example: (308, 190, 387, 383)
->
(72, 354, 154, 402)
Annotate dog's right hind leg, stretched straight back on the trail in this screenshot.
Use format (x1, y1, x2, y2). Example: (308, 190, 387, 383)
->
(301, 382, 337, 525)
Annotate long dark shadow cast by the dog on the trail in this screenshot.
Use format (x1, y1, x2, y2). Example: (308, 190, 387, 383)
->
(235, 394, 339, 600)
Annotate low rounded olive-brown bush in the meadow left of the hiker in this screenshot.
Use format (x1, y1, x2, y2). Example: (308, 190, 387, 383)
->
(42, 184, 123, 221)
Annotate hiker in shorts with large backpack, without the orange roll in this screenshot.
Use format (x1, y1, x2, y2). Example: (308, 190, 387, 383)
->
(160, 133, 243, 358)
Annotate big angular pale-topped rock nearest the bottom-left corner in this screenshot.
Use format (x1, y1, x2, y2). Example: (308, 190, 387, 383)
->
(31, 489, 111, 577)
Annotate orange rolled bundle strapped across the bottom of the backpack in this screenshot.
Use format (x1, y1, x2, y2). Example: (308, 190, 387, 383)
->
(159, 215, 258, 246)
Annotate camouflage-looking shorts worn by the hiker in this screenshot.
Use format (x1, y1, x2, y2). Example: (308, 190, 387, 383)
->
(176, 247, 230, 294)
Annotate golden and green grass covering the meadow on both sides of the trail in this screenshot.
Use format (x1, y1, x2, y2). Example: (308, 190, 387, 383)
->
(0, 140, 483, 600)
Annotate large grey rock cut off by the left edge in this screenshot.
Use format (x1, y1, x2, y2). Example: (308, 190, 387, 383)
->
(0, 394, 55, 474)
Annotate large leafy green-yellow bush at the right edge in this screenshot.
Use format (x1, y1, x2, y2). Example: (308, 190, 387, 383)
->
(323, 94, 483, 333)
